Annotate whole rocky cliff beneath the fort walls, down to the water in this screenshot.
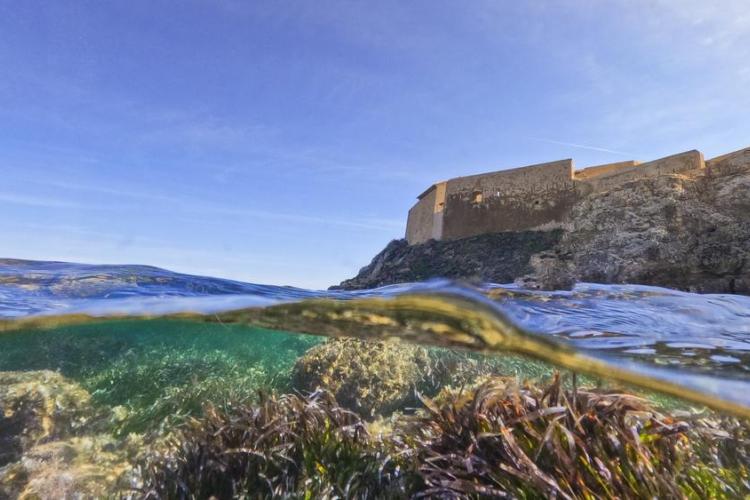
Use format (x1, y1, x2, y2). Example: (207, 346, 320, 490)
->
(340, 149, 750, 293)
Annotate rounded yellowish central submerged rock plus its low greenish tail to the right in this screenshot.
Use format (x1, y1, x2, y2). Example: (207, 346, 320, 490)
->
(292, 338, 551, 421)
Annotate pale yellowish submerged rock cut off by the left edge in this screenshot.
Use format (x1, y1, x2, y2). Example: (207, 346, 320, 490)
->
(0, 370, 93, 466)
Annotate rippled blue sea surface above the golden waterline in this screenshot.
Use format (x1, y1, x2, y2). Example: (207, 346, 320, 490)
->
(0, 260, 750, 375)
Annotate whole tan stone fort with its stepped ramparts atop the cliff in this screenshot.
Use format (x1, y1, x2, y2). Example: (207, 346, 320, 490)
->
(406, 149, 748, 245)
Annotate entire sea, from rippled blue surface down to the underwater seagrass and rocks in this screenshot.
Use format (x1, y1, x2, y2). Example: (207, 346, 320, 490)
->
(0, 260, 750, 499)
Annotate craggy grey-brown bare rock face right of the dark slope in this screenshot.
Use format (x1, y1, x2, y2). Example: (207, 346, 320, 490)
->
(548, 165, 750, 293)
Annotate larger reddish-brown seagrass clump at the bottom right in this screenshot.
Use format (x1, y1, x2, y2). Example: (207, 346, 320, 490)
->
(396, 375, 749, 498)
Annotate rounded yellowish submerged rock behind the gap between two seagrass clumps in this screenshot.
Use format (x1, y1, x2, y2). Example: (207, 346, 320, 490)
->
(292, 339, 430, 418)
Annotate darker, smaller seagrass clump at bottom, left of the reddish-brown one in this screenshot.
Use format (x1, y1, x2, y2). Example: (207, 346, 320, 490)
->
(140, 391, 414, 499)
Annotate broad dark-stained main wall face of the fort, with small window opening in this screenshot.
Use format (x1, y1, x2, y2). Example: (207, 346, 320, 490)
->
(442, 159, 579, 239)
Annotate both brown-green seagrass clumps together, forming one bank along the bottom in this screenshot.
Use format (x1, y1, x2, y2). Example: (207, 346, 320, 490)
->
(140, 374, 750, 499)
